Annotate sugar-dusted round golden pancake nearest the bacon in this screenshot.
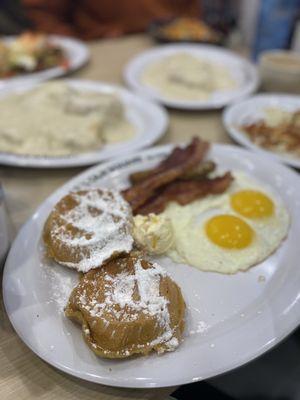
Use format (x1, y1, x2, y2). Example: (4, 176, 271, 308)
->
(43, 189, 133, 272)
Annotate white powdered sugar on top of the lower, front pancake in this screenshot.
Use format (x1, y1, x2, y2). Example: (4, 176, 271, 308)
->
(79, 259, 179, 351)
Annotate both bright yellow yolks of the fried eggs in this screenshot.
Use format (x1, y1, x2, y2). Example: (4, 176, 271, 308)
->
(205, 190, 274, 249)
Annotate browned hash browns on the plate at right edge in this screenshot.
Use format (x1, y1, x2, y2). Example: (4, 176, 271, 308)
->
(239, 107, 300, 157)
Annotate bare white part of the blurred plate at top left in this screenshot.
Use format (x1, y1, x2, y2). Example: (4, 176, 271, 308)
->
(0, 35, 90, 90)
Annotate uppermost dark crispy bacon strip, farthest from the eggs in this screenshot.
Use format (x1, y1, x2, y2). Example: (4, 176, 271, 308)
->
(123, 138, 209, 212)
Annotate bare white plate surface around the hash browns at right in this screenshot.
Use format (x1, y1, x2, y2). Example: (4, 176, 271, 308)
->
(223, 94, 300, 168)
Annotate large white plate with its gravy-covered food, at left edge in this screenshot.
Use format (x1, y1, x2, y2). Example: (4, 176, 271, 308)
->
(0, 80, 168, 168)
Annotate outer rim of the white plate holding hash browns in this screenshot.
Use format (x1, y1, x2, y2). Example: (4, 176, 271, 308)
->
(222, 92, 300, 169)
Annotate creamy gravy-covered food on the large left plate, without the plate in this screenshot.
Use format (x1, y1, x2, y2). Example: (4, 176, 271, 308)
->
(0, 81, 135, 157)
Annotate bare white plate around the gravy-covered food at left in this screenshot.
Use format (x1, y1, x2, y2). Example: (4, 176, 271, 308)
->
(0, 80, 168, 168)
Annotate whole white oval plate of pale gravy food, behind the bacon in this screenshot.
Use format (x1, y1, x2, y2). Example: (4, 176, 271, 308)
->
(124, 44, 259, 110)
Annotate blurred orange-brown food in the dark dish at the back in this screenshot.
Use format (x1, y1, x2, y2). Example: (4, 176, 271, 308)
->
(152, 17, 222, 43)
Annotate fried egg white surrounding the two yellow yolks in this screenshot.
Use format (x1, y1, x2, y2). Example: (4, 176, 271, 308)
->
(164, 173, 290, 274)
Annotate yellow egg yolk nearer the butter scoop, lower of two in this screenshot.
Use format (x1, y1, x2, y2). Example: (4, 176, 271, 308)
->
(205, 214, 254, 249)
